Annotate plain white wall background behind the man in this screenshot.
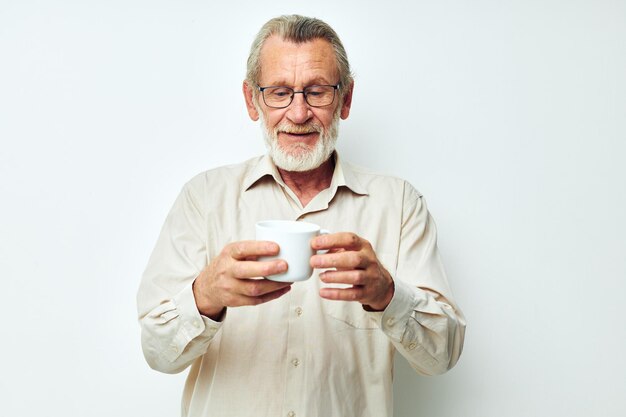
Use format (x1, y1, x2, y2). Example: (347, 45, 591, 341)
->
(0, 0, 626, 417)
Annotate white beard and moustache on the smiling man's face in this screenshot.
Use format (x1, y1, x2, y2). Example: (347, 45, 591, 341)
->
(259, 107, 341, 172)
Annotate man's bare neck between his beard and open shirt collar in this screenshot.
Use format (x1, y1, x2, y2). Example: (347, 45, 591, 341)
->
(278, 156, 335, 207)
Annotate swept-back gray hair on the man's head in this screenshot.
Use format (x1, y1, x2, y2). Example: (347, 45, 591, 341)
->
(246, 14, 353, 91)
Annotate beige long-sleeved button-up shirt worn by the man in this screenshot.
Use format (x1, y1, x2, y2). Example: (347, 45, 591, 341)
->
(137, 156, 465, 417)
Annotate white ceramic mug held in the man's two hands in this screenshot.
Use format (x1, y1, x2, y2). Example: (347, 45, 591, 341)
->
(256, 220, 330, 282)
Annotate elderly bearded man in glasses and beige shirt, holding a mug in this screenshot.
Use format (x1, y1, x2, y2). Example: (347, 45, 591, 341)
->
(138, 16, 465, 417)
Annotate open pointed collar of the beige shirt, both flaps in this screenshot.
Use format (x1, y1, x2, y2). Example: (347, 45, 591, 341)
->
(243, 151, 369, 195)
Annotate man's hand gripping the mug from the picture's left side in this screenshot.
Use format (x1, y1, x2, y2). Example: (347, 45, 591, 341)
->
(193, 240, 292, 320)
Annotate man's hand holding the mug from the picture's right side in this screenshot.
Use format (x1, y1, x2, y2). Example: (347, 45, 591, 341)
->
(311, 233, 394, 311)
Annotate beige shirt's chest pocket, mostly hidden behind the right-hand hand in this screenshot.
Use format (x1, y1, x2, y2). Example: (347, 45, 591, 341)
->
(324, 254, 395, 330)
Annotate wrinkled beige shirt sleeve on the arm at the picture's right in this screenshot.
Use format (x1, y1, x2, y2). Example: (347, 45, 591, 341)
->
(380, 184, 465, 375)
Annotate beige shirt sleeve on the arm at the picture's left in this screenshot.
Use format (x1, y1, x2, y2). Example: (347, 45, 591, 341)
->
(137, 179, 221, 373)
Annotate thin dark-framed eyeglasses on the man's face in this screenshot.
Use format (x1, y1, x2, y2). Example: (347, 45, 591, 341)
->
(257, 84, 339, 109)
